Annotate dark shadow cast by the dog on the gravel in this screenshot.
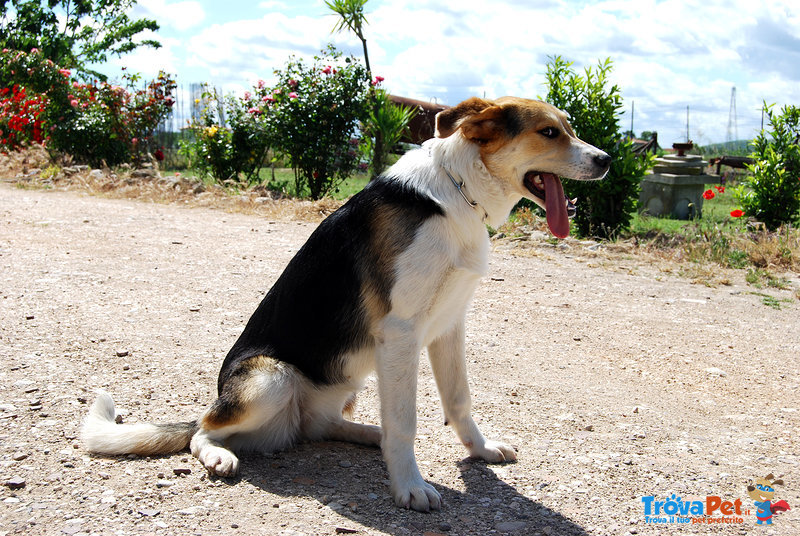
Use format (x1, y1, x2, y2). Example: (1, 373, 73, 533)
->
(226, 442, 588, 535)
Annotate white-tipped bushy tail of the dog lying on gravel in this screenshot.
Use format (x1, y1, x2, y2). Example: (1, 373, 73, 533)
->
(81, 391, 197, 456)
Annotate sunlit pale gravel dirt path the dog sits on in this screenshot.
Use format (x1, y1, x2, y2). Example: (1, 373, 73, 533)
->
(0, 185, 800, 535)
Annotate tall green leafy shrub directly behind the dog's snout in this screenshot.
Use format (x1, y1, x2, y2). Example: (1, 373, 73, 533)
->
(546, 56, 651, 238)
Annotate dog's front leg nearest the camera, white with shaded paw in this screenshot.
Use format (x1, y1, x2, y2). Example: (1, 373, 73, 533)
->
(376, 318, 442, 512)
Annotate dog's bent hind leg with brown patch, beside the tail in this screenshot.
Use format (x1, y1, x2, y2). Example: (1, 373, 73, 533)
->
(190, 356, 302, 476)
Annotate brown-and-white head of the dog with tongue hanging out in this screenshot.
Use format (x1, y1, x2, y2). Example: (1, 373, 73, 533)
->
(436, 97, 611, 238)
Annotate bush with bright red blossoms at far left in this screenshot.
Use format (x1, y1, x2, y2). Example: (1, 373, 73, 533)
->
(0, 49, 176, 165)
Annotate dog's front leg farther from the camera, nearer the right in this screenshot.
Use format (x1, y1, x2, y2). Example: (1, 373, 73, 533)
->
(428, 319, 517, 462)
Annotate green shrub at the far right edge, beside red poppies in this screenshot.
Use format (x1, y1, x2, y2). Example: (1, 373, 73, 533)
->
(736, 103, 800, 230)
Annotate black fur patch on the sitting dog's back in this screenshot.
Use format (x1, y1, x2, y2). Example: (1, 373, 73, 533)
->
(217, 177, 444, 394)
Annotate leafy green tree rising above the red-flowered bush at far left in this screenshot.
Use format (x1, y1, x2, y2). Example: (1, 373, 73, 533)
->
(0, 0, 161, 85)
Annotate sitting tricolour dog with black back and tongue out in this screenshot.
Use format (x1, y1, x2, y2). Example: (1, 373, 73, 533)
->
(82, 97, 611, 511)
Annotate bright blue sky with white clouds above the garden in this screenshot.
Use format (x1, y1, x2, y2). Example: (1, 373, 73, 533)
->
(95, 0, 800, 147)
